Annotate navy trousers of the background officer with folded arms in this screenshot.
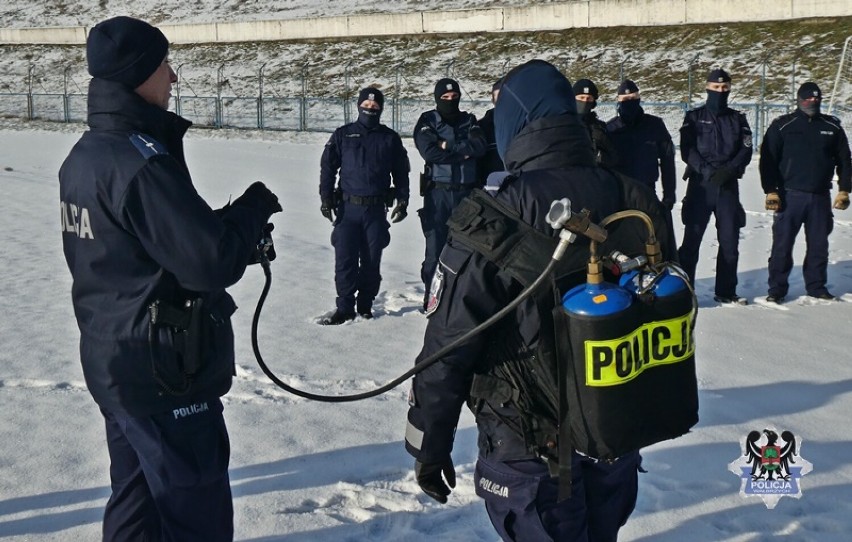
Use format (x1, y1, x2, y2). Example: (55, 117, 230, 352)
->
(417, 188, 474, 295)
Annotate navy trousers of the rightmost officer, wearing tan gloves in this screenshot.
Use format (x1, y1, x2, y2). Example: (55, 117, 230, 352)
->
(769, 190, 834, 297)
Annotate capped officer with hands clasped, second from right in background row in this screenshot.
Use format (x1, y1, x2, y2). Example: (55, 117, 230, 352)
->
(679, 69, 752, 305)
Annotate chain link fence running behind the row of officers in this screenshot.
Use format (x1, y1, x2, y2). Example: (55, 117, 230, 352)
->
(0, 64, 852, 147)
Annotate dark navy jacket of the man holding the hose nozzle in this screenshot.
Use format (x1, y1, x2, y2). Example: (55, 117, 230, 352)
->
(59, 79, 268, 416)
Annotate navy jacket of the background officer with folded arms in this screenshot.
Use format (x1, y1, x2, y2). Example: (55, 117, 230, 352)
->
(414, 109, 487, 186)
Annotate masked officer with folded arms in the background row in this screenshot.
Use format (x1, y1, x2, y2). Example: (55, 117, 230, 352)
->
(414, 78, 487, 310)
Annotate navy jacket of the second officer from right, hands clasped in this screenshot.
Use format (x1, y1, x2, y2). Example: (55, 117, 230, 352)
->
(680, 106, 752, 180)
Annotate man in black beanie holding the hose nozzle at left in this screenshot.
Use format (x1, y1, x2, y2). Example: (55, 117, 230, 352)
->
(59, 17, 281, 542)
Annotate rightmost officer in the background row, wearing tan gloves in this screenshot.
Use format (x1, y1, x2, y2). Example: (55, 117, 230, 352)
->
(760, 81, 852, 303)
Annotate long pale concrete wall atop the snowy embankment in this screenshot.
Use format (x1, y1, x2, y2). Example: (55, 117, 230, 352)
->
(0, 0, 852, 44)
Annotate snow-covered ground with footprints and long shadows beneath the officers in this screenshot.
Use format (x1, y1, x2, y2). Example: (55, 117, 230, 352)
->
(0, 124, 852, 542)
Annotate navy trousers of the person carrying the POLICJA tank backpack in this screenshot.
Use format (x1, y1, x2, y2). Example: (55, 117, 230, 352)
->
(474, 452, 641, 542)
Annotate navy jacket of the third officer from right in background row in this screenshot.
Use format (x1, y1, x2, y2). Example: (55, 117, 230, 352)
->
(606, 113, 676, 202)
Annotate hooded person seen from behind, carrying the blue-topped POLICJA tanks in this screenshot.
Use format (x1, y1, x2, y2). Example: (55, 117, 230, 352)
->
(405, 60, 694, 541)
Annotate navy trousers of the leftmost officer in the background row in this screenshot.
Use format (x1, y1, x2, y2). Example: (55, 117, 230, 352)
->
(331, 201, 390, 314)
